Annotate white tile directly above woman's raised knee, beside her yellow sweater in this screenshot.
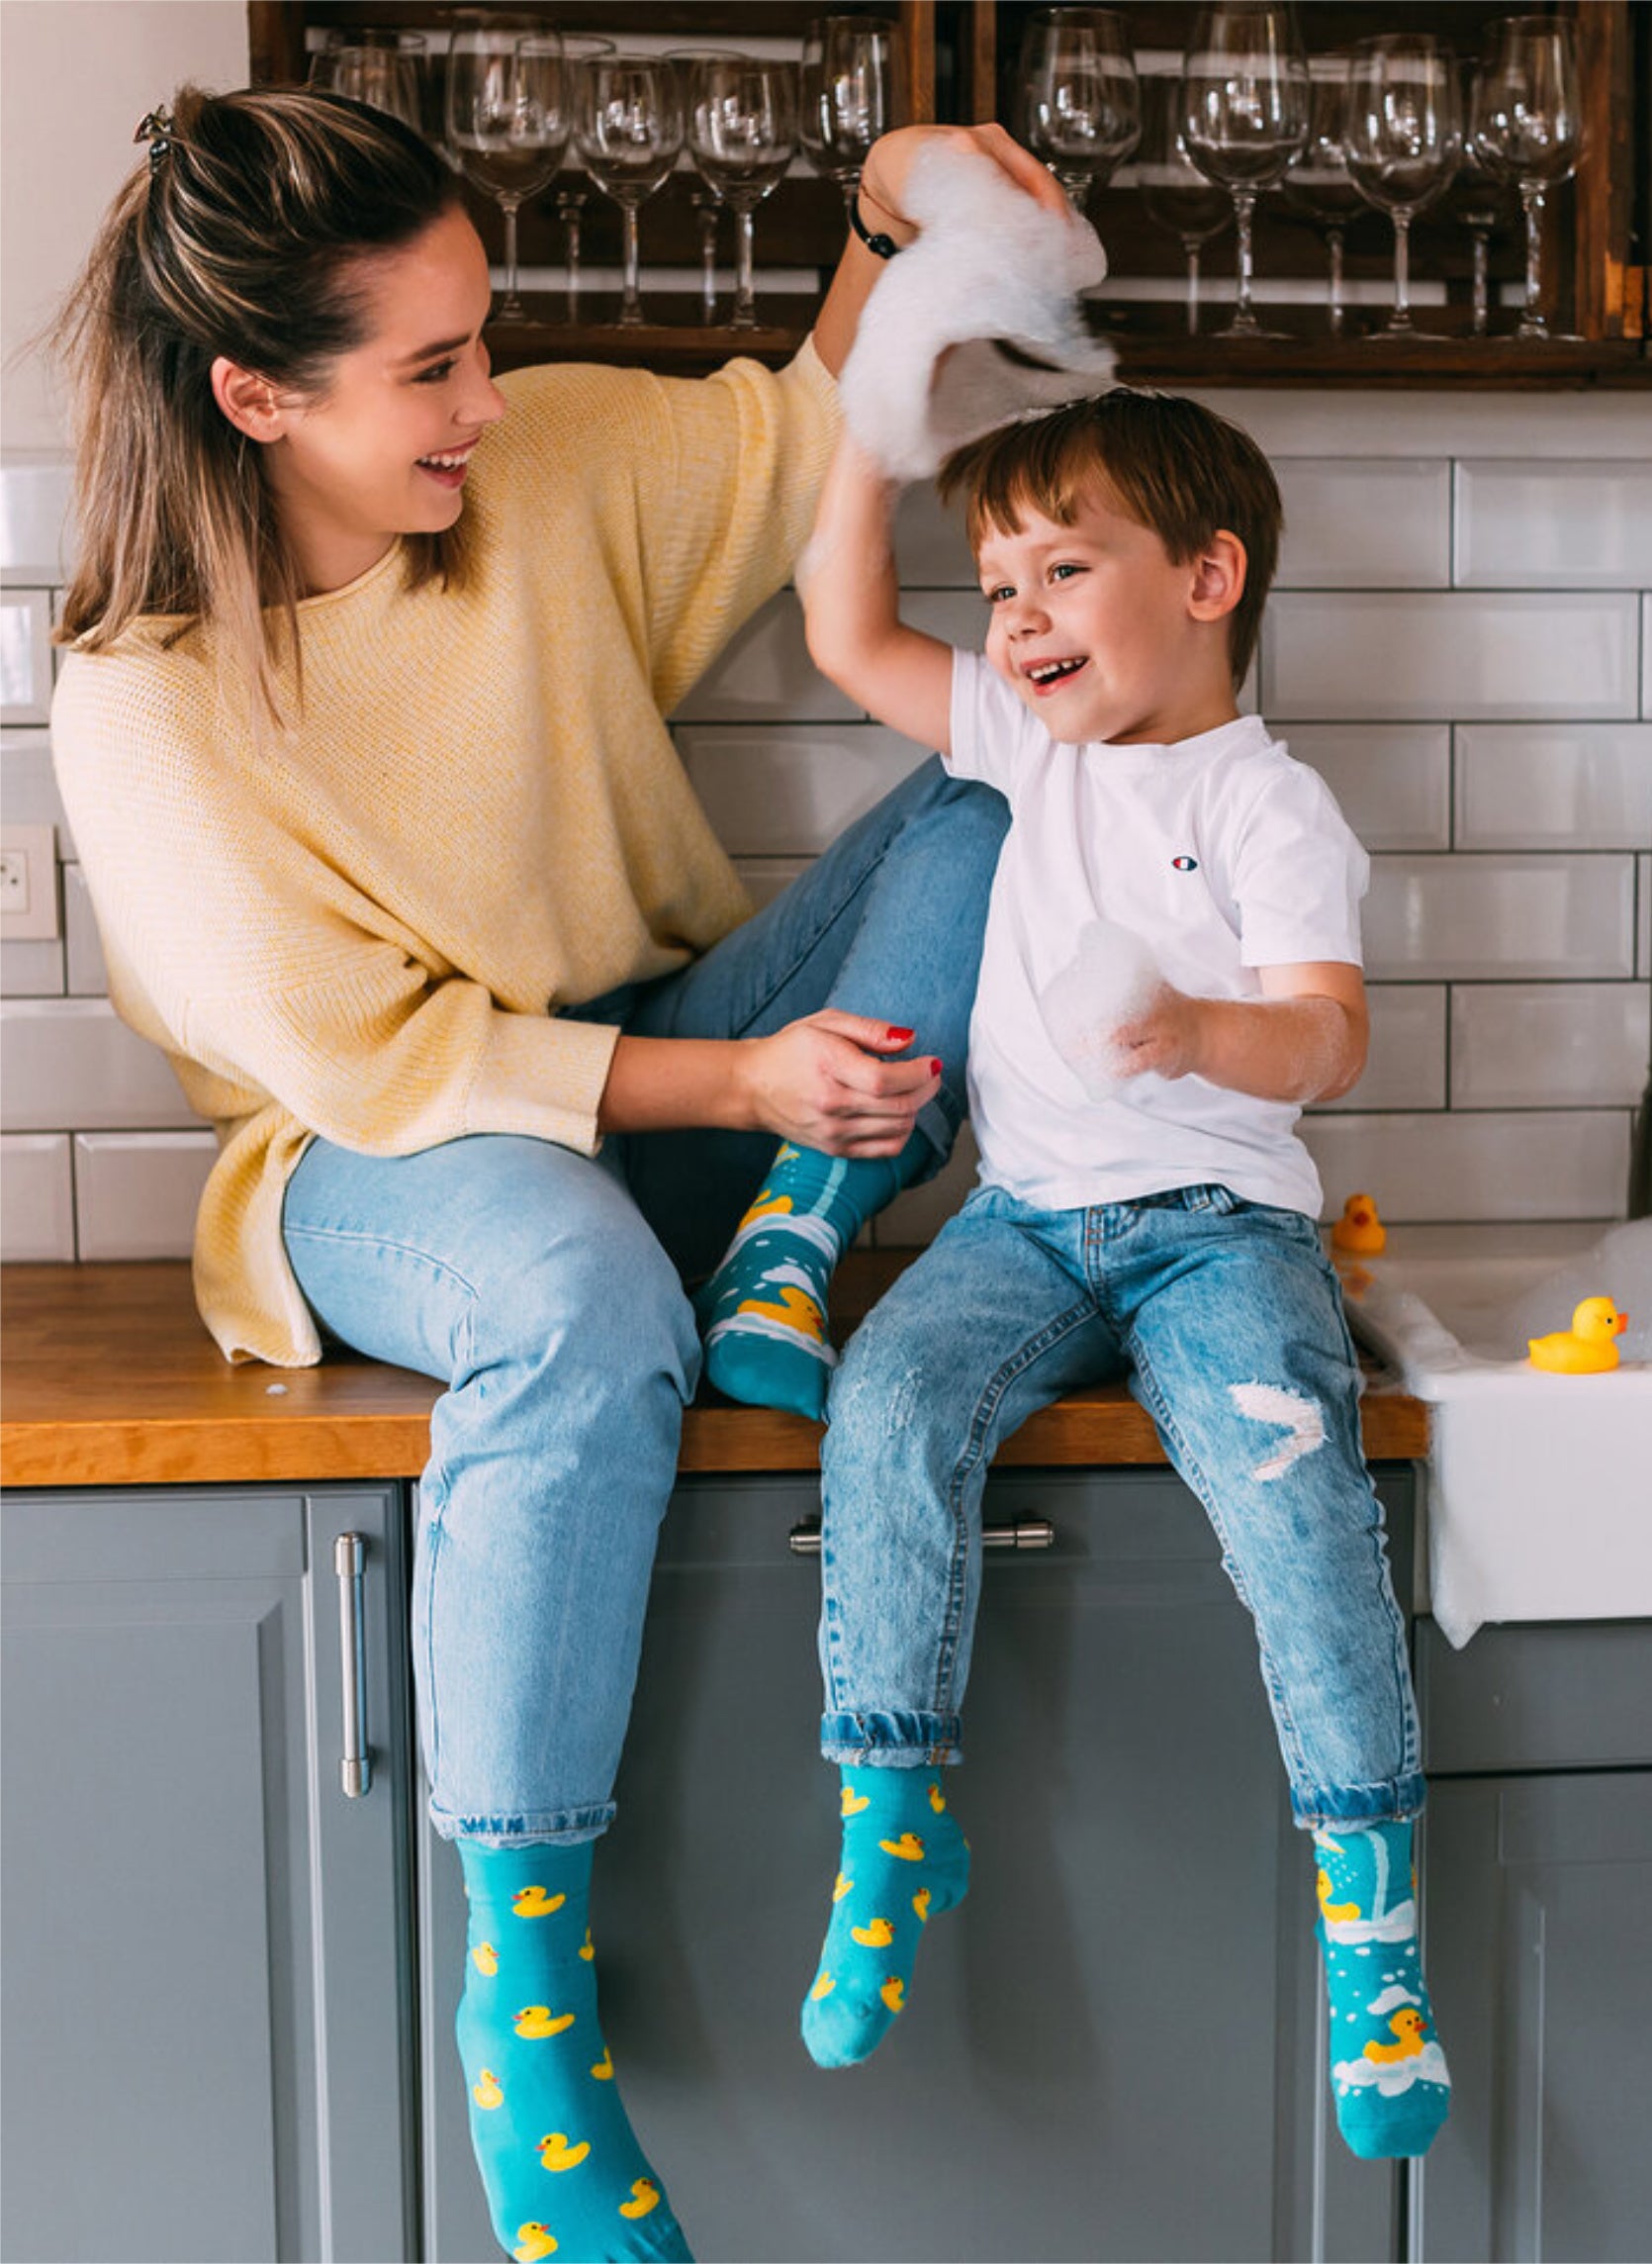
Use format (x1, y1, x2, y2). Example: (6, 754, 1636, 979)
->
(677, 722, 923, 856)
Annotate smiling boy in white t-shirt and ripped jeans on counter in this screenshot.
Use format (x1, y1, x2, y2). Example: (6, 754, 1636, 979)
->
(799, 392, 1450, 2157)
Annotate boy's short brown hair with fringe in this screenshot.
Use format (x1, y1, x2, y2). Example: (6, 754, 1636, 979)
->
(939, 385, 1285, 691)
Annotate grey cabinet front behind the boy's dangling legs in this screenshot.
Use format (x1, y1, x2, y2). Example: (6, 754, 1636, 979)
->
(421, 1469, 1410, 2264)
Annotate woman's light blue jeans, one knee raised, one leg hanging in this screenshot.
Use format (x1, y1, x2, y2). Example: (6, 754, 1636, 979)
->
(283, 761, 1007, 1845)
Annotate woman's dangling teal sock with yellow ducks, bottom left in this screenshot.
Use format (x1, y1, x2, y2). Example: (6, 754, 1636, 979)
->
(457, 1840, 688, 2264)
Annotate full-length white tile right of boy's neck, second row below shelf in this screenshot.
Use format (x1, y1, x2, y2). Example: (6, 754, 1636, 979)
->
(1263, 591, 1638, 722)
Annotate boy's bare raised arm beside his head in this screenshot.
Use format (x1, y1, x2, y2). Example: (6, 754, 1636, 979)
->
(796, 434, 953, 754)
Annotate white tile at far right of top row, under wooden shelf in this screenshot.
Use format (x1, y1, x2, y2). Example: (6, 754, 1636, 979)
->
(1453, 459, 1652, 589)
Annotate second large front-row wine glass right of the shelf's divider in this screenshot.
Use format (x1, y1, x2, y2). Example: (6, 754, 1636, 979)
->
(1181, 0, 1311, 337)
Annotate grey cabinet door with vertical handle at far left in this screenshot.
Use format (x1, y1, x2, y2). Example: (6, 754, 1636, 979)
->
(0, 1485, 416, 2264)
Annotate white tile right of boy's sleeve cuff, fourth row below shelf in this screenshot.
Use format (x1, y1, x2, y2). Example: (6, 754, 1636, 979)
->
(1364, 856, 1634, 981)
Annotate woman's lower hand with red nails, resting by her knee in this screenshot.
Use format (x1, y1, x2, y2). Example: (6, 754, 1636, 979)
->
(738, 1007, 942, 1157)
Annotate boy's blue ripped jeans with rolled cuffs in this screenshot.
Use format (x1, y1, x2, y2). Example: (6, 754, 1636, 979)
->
(819, 1186, 1423, 1827)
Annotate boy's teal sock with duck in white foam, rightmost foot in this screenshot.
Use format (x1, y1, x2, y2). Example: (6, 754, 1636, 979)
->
(1313, 1823, 1450, 2162)
